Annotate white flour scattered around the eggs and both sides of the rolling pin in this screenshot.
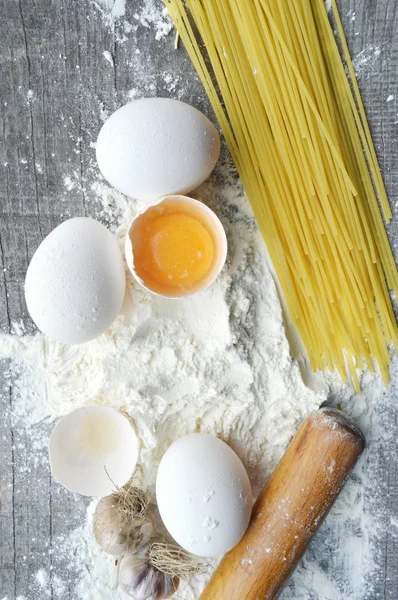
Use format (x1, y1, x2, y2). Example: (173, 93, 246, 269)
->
(0, 163, 387, 600)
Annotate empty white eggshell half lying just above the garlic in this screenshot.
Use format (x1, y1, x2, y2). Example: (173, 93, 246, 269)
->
(50, 405, 140, 496)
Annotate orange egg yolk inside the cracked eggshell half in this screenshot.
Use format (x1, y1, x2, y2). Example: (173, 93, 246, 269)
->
(134, 214, 214, 287)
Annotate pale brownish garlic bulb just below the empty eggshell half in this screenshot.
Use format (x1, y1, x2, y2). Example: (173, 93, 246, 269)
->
(93, 488, 153, 556)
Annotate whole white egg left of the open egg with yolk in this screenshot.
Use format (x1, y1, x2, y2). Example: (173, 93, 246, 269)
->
(25, 217, 126, 344)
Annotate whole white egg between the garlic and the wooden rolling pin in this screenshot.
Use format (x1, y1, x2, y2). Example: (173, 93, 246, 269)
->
(156, 434, 252, 557)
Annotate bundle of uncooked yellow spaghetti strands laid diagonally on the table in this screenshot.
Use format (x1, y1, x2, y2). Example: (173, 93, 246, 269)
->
(166, 0, 398, 388)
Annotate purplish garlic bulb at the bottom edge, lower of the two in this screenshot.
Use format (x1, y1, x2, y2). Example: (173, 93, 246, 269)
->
(119, 553, 180, 600)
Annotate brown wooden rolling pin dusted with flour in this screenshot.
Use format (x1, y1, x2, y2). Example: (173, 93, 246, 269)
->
(200, 408, 365, 600)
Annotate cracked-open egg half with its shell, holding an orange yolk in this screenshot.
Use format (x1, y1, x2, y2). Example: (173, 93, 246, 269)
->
(125, 196, 227, 298)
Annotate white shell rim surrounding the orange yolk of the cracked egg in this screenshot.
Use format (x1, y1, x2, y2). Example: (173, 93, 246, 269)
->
(125, 195, 228, 298)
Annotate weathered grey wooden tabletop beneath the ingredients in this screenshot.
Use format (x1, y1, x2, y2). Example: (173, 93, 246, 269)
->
(0, 0, 398, 600)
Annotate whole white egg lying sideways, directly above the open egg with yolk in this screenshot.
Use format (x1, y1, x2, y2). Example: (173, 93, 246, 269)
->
(96, 98, 220, 201)
